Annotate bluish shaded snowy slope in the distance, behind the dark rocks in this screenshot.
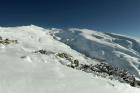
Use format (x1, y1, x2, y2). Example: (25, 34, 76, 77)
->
(50, 29, 140, 77)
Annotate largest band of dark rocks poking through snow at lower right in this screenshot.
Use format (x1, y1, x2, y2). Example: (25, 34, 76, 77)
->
(80, 63, 140, 86)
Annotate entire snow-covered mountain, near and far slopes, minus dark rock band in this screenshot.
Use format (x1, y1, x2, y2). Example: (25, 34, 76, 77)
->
(0, 25, 140, 93)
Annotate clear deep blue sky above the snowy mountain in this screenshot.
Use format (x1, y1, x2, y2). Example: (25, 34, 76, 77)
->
(0, 0, 140, 37)
